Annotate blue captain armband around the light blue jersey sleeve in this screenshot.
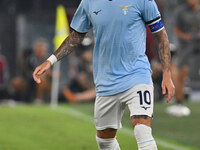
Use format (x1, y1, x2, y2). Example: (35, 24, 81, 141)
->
(147, 17, 164, 33)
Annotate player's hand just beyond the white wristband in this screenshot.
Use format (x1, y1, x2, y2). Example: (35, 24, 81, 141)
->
(33, 60, 51, 84)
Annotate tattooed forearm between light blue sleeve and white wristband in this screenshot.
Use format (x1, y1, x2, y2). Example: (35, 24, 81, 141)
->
(54, 30, 85, 60)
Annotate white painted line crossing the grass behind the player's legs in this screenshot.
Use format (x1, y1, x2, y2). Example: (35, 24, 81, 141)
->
(53, 107, 190, 150)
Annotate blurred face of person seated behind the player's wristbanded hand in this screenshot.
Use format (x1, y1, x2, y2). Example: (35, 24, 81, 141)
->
(34, 42, 47, 58)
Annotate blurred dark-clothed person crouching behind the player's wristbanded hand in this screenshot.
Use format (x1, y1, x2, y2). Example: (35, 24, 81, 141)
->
(11, 38, 51, 103)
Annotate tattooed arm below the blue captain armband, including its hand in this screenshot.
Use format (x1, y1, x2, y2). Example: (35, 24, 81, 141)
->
(154, 29, 175, 102)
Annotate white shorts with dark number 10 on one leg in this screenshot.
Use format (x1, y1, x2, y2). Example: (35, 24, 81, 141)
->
(94, 84, 154, 130)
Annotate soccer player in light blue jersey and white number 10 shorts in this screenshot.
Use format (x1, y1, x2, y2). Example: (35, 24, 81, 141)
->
(33, 0, 175, 150)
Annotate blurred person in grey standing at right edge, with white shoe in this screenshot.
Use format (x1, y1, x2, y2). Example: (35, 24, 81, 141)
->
(167, 0, 200, 116)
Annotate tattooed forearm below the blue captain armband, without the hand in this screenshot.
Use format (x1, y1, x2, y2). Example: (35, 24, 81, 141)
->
(154, 29, 171, 72)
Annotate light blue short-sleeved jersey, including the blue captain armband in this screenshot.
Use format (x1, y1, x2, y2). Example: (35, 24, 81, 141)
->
(71, 0, 163, 96)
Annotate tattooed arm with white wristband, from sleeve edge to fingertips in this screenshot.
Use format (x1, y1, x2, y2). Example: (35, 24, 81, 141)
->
(33, 30, 85, 83)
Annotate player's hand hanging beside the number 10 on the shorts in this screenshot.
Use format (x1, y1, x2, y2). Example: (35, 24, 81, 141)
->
(162, 71, 175, 103)
